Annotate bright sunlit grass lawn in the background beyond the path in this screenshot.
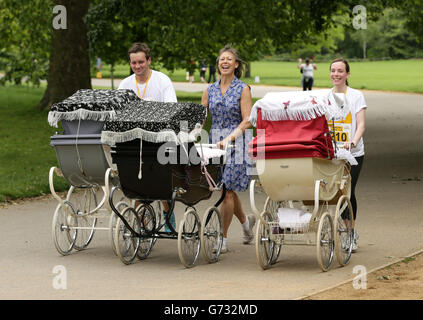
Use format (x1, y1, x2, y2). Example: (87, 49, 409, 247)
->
(93, 59, 423, 93)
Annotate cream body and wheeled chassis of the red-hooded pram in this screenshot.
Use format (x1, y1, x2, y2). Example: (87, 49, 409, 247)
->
(250, 158, 353, 271)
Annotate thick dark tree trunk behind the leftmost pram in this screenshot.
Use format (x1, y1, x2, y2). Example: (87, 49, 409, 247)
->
(37, 0, 91, 109)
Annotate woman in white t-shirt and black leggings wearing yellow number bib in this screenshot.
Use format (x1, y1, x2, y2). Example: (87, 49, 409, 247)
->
(329, 58, 367, 252)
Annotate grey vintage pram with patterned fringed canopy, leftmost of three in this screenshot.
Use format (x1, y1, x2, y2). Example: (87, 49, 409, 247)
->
(48, 89, 142, 255)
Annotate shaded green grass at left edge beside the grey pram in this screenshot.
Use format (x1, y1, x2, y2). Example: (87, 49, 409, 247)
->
(0, 86, 66, 201)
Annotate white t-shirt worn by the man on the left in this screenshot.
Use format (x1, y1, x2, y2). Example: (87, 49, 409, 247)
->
(118, 70, 177, 102)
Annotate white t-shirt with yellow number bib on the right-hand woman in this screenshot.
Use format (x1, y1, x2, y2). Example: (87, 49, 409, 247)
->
(328, 87, 367, 157)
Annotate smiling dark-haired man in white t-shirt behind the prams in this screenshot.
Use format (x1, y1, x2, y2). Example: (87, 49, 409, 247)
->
(118, 42, 177, 232)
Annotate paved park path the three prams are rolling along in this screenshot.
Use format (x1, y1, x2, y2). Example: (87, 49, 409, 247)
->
(0, 80, 423, 300)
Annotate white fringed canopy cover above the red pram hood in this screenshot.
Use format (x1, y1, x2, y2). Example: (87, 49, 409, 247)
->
(249, 89, 350, 126)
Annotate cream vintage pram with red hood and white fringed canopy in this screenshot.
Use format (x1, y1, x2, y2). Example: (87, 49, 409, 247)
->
(249, 90, 353, 271)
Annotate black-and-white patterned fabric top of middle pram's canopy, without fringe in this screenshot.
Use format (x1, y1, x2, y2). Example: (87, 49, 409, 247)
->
(104, 100, 207, 134)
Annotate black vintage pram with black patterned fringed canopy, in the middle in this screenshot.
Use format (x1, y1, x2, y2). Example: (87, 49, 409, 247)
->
(102, 100, 229, 267)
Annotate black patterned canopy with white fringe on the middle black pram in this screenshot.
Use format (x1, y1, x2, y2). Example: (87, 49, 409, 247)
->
(101, 99, 207, 146)
